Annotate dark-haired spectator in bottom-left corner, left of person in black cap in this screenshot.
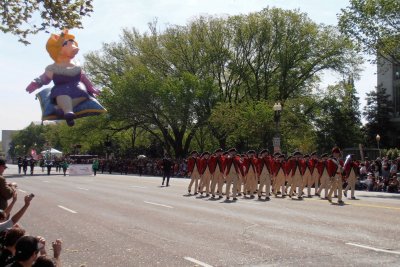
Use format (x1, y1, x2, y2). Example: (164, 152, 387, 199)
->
(0, 227, 25, 266)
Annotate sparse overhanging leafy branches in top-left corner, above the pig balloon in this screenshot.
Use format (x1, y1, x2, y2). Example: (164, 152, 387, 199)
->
(0, 0, 93, 44)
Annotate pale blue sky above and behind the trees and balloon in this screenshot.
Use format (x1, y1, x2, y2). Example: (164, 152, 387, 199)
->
(0, 0, 376, 134)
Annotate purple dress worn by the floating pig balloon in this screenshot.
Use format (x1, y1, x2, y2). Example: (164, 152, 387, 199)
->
(46, 64, 90, 104)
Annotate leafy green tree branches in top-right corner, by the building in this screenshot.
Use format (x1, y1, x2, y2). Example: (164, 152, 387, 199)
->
(339, 0, 400, 64)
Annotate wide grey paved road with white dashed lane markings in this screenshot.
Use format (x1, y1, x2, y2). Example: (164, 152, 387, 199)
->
(6, 166, 400, 267)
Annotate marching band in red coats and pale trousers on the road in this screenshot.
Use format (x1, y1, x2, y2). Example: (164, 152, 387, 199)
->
(188, 147, 359, 204)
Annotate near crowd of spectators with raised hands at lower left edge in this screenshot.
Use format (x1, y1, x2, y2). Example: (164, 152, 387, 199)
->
(0, 159, 62, 267)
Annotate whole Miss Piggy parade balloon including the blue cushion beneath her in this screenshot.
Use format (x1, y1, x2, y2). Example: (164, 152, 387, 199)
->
(26, 30, 106, 126)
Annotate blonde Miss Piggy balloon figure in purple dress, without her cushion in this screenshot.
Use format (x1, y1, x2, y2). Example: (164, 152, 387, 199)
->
(26, 30, 100, 126)
